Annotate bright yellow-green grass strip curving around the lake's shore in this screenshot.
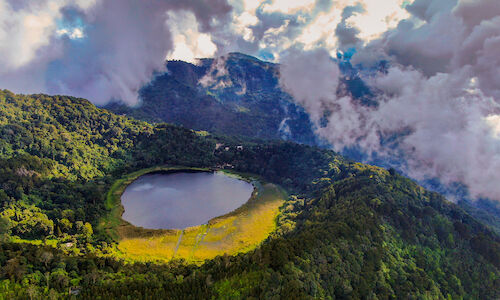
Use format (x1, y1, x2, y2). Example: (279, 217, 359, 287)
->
(105, 168, 286, 263)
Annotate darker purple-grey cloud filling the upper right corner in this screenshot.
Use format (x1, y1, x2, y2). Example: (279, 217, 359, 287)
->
(352, 0, 500, 99)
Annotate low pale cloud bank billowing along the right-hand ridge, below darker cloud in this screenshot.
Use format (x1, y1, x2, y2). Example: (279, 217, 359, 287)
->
(280, 45, 500, 200)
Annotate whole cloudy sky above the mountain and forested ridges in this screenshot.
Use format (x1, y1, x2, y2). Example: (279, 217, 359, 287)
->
(0, 0, 500, 204)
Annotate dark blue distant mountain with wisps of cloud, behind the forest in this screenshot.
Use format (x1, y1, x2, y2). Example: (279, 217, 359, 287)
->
(105, 53, 318, 144)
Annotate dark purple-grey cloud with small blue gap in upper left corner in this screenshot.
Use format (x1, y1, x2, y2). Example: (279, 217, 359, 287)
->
(0, 0, 231, 104)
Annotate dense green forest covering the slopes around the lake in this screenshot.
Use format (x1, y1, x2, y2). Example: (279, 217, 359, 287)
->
(0, 90, 500, 299)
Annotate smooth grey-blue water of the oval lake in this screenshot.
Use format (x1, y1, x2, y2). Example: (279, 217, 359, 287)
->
(121, 172, 253, 229)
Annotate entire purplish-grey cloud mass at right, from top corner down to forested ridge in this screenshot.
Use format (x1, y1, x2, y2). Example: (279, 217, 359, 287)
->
(280, 0, 500, 200)
